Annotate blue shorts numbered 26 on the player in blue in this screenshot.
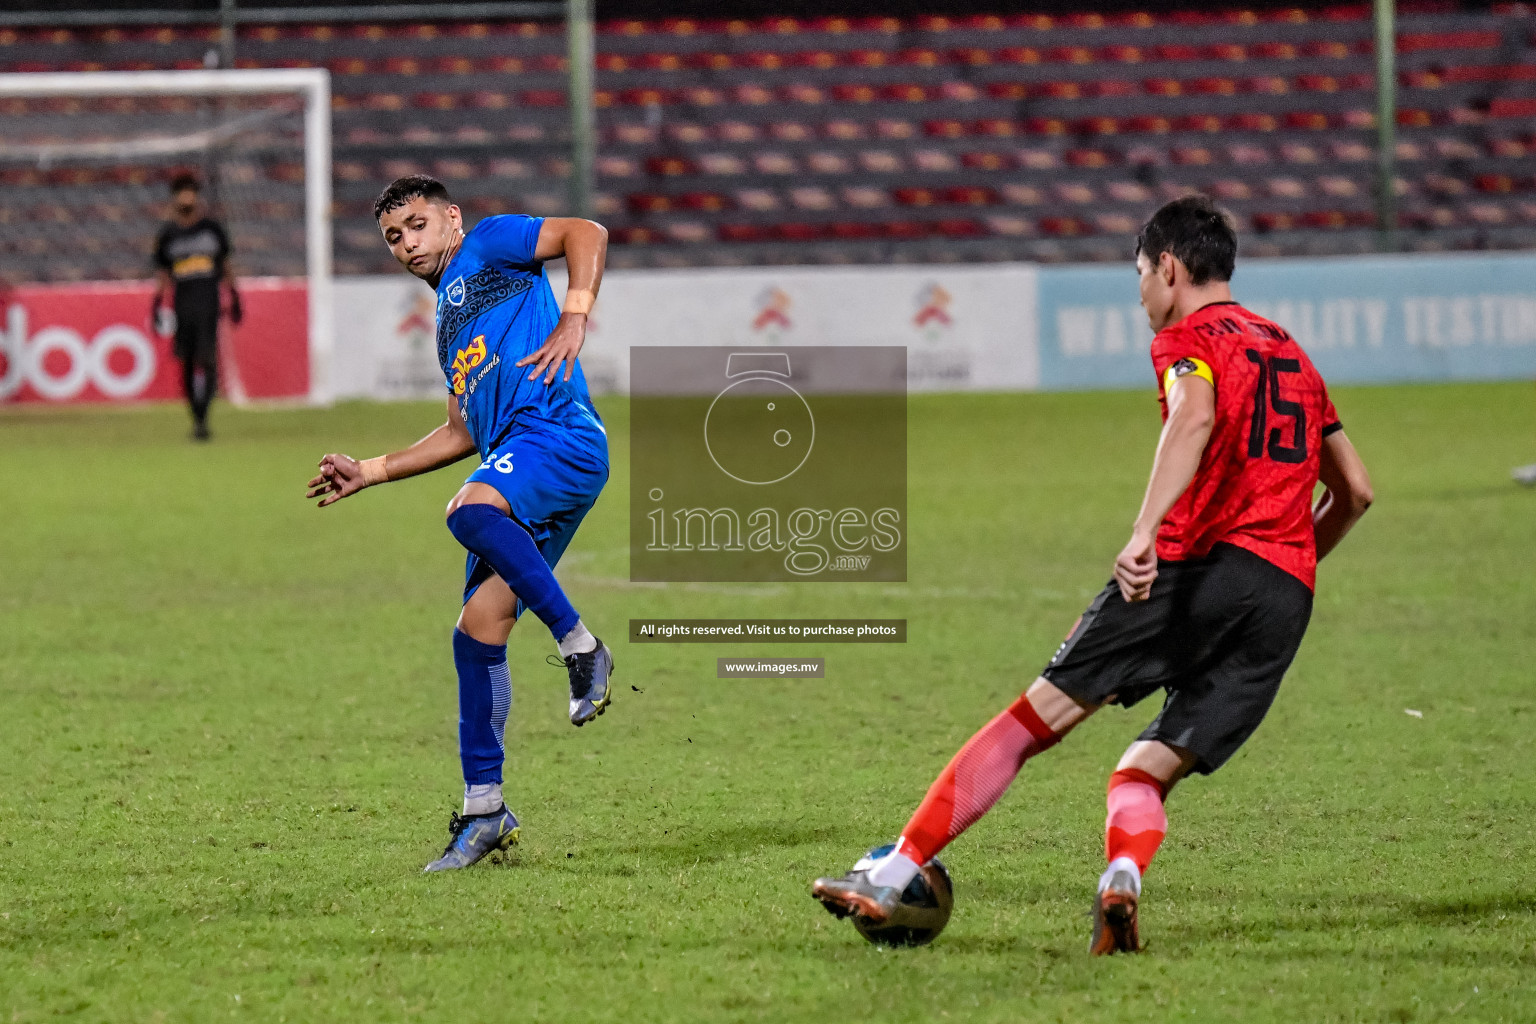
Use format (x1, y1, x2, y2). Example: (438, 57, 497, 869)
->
(464, 431, 608, 616)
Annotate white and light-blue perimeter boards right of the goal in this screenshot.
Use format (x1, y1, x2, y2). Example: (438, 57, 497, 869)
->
(332, 253, 1536, 399)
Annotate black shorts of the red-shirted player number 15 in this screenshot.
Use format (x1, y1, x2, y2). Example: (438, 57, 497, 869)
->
(1041, 543, 1312, 774)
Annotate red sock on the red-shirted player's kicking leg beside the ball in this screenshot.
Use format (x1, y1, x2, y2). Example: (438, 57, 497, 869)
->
(897, 697, 1061, 864)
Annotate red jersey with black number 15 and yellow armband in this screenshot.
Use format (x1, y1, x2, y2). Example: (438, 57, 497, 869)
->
(1152, 302, 1339, 586)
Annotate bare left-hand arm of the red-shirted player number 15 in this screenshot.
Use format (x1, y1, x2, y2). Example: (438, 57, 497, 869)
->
(1115, 373, 1217, 600)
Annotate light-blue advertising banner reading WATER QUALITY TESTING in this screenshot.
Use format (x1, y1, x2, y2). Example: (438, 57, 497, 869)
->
(1038, 253, 1536, 391)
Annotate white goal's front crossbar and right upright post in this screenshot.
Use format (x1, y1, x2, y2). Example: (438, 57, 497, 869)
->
(0, 68, 335, 404)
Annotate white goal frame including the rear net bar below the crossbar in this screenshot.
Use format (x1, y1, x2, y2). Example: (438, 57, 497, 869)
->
(0, 68, 335, 404)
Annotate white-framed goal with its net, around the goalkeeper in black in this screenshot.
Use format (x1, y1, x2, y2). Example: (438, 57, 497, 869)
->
(0, 69, 333, 402)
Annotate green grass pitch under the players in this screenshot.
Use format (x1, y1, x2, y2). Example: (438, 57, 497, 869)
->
(0, 384, 1536, 1024)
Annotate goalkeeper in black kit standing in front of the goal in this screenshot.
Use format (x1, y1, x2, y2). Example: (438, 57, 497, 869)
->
(151, 175, 241, 441)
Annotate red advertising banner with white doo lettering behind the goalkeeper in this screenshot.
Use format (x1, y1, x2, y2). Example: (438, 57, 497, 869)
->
(0, 278, 309, 404)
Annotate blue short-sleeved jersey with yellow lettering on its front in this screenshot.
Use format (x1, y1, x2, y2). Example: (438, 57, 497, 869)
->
(438, 215, 607, 457)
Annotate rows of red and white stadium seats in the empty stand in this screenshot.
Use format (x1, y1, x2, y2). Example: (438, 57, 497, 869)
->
(0, 3, 1536, 276)
